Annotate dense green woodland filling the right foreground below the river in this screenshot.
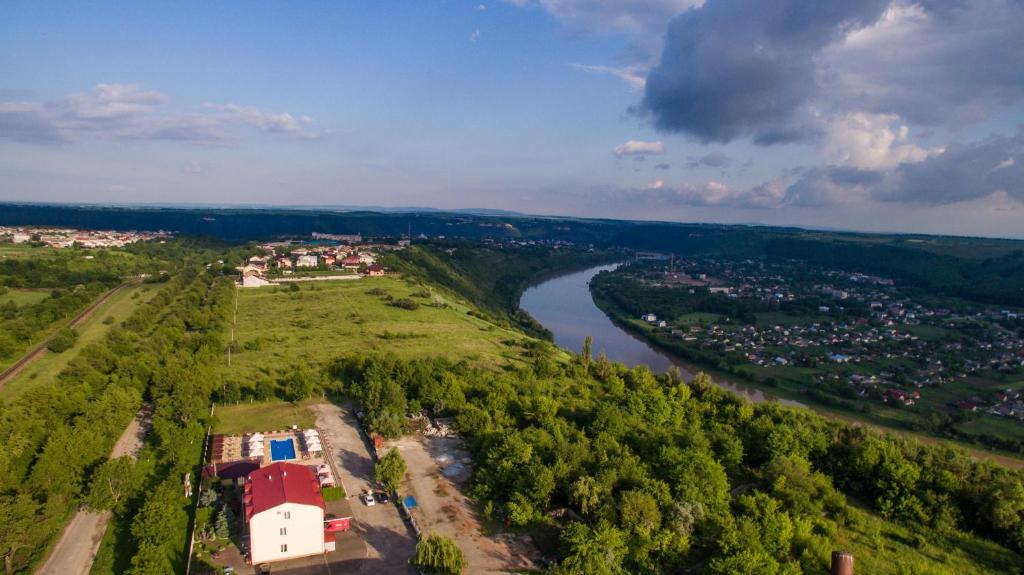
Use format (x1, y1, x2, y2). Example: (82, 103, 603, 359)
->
(331, 348, 1024, 575)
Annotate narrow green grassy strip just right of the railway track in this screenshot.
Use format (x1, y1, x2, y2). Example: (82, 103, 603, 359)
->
(0, 285, 157, 400)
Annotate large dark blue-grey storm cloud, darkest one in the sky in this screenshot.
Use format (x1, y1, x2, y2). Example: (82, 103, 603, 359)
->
(642, 0, 889, 143)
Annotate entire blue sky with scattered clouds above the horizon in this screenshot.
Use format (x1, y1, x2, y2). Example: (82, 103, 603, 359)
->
(0, 0, 1024, 238)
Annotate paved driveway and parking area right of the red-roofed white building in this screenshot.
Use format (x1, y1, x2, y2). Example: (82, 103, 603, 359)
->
(309, 403, 416, 575)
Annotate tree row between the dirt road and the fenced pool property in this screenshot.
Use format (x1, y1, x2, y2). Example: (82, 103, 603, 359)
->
(93, 273, 234, 575)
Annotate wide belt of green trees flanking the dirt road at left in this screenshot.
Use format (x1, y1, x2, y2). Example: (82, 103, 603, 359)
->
(0, 269, 229, 573)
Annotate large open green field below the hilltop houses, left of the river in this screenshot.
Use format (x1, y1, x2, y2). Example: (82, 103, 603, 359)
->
(225, 277, 528, 382)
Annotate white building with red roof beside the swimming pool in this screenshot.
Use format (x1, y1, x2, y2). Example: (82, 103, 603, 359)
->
(245, 462, 325, 565)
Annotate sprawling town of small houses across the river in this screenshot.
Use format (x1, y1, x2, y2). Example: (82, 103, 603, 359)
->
(597, 257, 1024, 429)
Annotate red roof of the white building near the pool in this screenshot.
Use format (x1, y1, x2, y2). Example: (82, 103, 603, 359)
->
(246, 461, 324, 521)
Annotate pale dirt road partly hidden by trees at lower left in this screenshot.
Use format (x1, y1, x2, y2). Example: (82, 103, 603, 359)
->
(36, 407, 151, 575)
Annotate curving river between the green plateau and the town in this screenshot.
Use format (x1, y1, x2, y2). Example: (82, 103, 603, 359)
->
(519, 264, 801, 406)
